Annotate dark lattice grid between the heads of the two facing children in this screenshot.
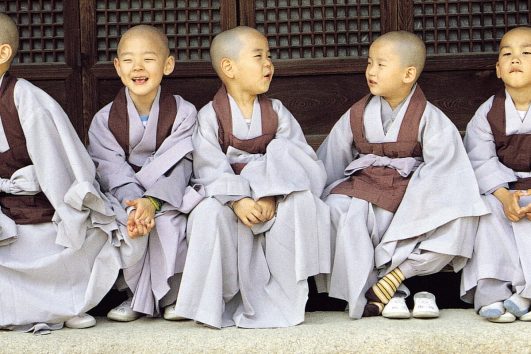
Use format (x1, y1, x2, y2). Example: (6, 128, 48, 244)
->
(255, 0, 380, 59)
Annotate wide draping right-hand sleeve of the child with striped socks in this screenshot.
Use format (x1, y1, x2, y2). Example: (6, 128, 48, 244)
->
(382, 103, 488, 242)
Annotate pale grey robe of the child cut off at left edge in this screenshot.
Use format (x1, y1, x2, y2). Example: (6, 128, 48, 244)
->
(0, 79, 120, 331)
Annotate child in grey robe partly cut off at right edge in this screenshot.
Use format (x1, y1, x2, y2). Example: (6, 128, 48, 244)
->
(461, 27, 531, 322)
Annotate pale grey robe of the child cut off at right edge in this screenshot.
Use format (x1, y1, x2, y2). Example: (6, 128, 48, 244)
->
(461, 92, 531, 308)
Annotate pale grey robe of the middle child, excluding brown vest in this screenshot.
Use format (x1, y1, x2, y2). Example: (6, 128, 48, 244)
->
(176, 97, 330, 328)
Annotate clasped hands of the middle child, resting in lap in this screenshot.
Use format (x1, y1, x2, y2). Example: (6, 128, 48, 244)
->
(232, 197, 277, 227)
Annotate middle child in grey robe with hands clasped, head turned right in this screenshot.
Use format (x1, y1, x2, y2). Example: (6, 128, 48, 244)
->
(176, 27, 329, 328)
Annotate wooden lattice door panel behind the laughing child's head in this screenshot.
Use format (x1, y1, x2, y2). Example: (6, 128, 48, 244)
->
(80, 0, 237, 141)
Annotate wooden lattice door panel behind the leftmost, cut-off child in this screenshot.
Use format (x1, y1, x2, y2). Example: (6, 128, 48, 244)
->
(0, 0, 83, 135)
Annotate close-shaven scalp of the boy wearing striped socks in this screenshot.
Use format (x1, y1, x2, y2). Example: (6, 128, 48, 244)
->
(374, 31, 426, 78)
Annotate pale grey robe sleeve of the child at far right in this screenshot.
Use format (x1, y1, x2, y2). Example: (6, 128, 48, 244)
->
(464, 97, 517, 194)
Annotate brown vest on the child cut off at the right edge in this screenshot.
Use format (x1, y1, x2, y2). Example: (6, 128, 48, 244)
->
(487, 89, 531, 189)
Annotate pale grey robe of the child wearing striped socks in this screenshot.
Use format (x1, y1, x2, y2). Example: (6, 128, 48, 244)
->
(317, 88, 487, 318)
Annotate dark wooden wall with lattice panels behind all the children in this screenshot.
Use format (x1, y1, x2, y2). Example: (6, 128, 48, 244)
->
(0, 0, 531, 146)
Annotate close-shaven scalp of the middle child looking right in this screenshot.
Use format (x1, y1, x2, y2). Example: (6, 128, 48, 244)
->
(210, 26, 263, 74)
